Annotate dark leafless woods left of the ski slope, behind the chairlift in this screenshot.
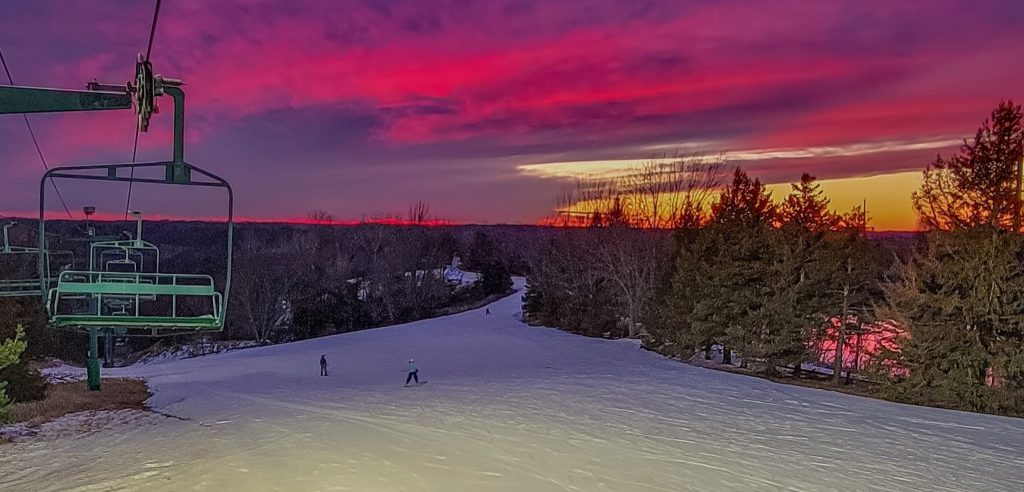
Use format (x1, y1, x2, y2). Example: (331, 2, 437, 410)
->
(0, 216, 531, 421)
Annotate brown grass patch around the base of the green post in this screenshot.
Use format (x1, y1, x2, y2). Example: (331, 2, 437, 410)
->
(12, 378, 150, 425)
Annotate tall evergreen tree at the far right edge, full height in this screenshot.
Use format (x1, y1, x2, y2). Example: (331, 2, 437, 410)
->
(883, 101, 1024, 413)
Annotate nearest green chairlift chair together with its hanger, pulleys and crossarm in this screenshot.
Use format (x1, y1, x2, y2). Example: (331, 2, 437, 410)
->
(0, 62, 234, 390)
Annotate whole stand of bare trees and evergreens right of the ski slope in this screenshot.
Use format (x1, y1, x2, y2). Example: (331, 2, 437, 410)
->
(524, 101, 1024, 415)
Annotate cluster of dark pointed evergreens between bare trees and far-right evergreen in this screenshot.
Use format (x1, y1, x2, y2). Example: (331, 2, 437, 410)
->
(654, 170, 886, 372)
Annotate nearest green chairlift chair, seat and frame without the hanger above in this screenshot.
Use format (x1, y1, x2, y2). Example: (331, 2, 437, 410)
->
(40, 161, 233, 336)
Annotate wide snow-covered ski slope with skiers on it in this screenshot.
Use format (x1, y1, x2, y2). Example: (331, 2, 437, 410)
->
(0, 279, 1024, 491)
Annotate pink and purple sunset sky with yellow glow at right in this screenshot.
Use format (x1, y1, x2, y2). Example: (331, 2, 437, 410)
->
(0, 0, 1024, 230)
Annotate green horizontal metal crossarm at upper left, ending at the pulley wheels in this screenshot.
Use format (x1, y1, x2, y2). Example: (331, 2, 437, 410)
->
(0, 85, 132, 115)
